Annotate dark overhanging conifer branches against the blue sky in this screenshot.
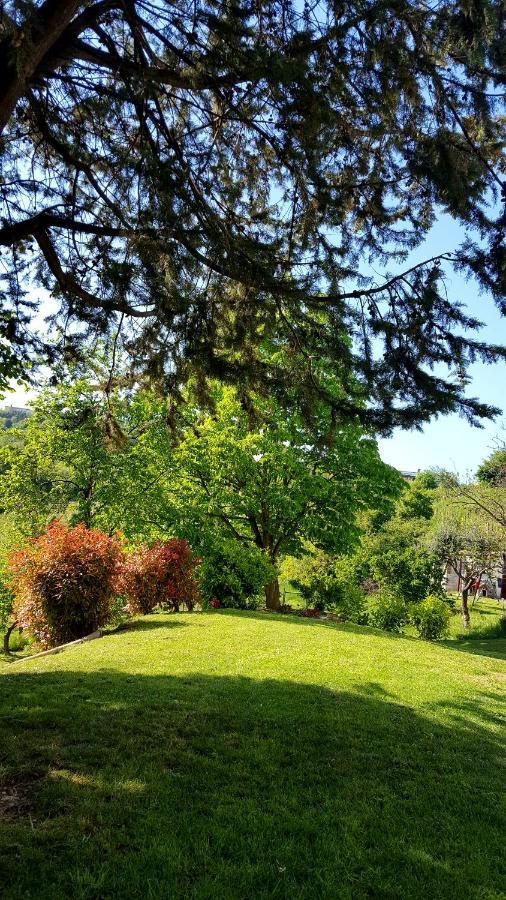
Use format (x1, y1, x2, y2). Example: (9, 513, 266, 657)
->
(0, 0, 506, 432)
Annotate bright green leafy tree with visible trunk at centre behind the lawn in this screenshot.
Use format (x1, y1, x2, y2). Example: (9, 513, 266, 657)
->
(140, 388, 400, 609)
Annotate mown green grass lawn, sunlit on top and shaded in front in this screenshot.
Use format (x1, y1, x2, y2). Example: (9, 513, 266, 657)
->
(0, 611, 506, 900)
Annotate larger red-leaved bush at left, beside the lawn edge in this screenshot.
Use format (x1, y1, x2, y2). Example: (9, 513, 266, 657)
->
(9, 521, 122, 647)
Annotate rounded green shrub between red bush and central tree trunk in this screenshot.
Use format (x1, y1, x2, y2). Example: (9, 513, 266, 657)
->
(200, 541, 275, 609)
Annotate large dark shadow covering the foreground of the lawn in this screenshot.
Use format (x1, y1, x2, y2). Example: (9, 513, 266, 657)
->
(0, 670, 504, 900)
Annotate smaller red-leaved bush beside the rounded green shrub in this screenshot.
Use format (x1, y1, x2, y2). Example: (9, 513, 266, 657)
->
(117, 538, 199, 615)
